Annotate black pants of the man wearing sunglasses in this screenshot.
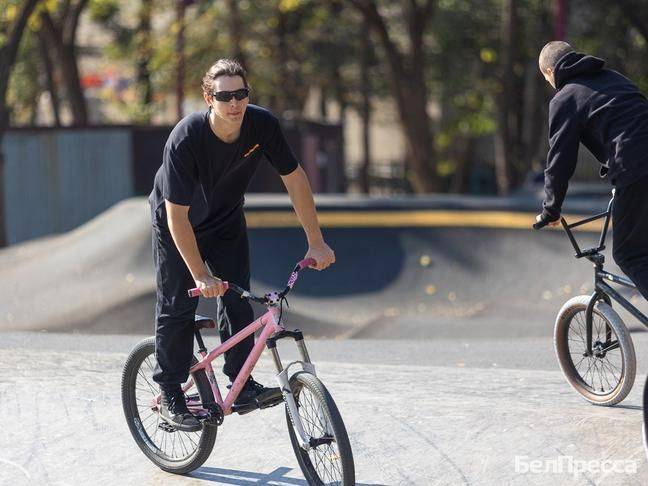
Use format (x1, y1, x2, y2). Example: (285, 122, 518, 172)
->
(153, 214, 254, 385)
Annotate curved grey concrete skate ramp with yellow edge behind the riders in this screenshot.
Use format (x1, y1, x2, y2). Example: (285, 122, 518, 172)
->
(0, 195, 645, 339)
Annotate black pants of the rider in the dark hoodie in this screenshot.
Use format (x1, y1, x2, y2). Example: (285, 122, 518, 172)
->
(612, 177, 648, 299)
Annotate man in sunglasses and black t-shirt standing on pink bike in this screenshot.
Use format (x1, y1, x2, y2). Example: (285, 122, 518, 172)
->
(149, 59, 335, 431)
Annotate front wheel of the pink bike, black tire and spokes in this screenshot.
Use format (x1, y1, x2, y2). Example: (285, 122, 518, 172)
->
(286, 371, 355, 486)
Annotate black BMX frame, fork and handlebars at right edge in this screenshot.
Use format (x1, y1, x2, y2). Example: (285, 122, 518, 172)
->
(560, 190, 648, 356)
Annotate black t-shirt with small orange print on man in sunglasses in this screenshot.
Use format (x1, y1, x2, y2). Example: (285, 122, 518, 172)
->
(149, 105, 299, 236)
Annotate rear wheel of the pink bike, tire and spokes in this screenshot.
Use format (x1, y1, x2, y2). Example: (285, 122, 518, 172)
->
(121, 337, 218, 474)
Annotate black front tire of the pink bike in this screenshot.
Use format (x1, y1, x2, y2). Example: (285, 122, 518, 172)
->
(286, 371, 355, 486)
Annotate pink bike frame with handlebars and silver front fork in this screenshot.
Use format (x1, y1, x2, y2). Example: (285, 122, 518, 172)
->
(154, 259, 316, 450)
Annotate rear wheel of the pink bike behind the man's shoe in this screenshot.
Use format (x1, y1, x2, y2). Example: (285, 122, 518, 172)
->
(121, 337, 218, 474)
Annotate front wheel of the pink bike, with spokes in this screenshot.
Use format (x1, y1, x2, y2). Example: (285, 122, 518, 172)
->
(286, 372, 355, 486)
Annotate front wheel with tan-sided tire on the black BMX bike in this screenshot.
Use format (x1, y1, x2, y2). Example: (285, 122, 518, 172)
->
(554, 295, 636, 406)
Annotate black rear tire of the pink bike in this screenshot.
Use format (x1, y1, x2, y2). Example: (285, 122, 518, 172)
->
(121, 337, 218, 474)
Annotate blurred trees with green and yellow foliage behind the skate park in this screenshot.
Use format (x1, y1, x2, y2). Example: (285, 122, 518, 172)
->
(5, 0, 648, 193)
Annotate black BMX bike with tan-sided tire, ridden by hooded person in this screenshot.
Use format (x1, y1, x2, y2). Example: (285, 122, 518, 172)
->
(554, 191, 648, 406)
